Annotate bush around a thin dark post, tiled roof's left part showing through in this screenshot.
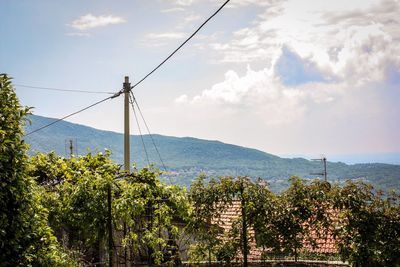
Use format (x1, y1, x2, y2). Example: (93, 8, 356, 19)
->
(189, 176, 259, 266)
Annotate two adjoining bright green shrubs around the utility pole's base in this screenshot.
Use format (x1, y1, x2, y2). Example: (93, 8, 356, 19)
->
(30, 151, 189, 264)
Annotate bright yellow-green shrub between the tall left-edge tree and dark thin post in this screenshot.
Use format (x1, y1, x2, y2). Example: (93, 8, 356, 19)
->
(30, 151, 120, 262)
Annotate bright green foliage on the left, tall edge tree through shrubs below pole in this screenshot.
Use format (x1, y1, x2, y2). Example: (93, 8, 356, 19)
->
(0, 75, 189, 266)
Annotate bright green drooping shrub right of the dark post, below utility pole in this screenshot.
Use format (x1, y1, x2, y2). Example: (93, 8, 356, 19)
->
(113, 168, 190, 265)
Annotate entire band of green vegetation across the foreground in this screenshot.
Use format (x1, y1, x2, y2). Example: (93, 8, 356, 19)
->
(0, 75, 400, 267)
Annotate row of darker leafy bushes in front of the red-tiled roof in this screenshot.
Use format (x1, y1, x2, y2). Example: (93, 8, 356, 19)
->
(189, 177, 400, 267)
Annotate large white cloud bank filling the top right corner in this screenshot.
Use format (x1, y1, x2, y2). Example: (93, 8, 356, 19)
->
(209, 0, 400, 86)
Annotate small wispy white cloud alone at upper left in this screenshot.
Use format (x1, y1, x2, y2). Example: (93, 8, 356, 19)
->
(69, 13, 125, 31)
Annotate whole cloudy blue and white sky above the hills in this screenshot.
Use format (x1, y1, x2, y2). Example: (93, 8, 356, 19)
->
(0, 0, 400, 163)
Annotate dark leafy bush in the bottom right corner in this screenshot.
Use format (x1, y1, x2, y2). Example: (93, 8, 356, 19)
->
(335, 181, 400, 267)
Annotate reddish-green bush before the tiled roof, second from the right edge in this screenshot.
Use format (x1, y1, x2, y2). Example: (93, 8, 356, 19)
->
(253, 176, 332, 261)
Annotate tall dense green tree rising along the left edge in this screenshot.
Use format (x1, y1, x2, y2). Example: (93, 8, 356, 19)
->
(0, 74, 68, 266)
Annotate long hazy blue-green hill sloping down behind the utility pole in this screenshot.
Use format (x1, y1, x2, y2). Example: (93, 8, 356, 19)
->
(26, 115, 400, 191)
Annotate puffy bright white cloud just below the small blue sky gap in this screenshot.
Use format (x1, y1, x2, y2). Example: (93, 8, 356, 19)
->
(175, 67, 343, 125)
